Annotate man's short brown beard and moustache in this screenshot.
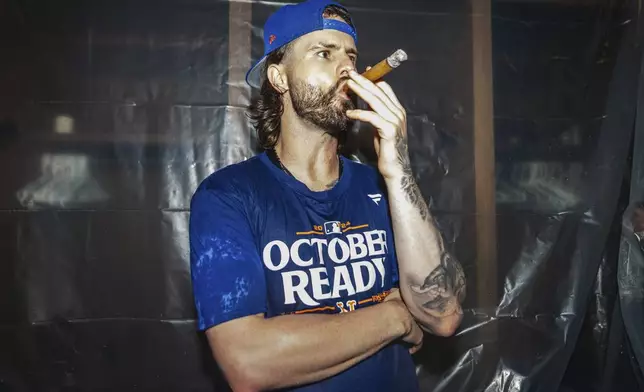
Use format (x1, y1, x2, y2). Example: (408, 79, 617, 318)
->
(291, 78, 355, 137)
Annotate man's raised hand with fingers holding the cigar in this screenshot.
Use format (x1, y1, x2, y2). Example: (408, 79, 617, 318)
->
(347, 71, 411, 180)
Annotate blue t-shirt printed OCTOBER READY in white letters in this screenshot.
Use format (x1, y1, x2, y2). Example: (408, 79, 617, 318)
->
(190, 153, 418, 392)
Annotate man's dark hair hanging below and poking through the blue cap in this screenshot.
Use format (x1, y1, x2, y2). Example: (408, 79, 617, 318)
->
(249, 5, 354, 149)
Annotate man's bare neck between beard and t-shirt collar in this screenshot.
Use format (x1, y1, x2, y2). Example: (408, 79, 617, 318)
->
(275, 112, 340, 191)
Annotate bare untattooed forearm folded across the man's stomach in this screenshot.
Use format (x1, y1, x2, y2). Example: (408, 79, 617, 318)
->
(213, 301, 411, 392)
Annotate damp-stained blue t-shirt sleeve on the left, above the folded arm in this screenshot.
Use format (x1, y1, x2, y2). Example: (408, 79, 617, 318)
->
(189, 188, 266, 331)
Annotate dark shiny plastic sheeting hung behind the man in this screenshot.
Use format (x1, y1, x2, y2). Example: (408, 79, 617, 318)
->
(0, 0, 644, 392)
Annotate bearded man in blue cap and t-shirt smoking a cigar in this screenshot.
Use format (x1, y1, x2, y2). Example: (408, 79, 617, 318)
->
(190, 0, 465, 392)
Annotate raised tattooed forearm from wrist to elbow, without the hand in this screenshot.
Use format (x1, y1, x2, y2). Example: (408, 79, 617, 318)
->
(386, 155, 465, 335)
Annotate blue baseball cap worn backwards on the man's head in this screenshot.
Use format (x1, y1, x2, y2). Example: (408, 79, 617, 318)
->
(246, 0, 358, 88)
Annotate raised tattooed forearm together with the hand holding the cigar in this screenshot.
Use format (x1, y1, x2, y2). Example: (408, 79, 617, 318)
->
(347, 64, 465, 335)
